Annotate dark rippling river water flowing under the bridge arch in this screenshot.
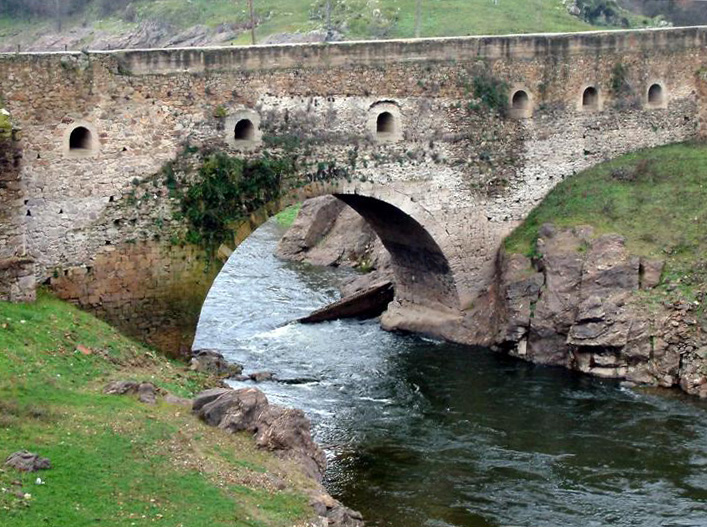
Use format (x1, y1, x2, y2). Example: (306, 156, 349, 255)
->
(196, 221, 707, 527)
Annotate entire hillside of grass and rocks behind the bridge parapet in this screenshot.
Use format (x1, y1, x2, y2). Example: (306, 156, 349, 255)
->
(0, 0, 657, 51)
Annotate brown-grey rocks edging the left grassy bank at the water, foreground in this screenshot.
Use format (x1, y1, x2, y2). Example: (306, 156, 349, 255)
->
(192, 388, 363, 527)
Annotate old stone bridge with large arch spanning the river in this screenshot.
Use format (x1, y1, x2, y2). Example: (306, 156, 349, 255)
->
(0, 27, 707, 347)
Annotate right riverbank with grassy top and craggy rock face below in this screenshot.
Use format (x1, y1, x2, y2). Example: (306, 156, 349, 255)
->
(496, 140, 707, 398)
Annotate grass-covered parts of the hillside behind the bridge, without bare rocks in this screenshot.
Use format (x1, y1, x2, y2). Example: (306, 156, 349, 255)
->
(0, 0, 645, 49)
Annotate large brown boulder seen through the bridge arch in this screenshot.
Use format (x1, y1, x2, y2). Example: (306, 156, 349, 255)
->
(276, 196, 393, 296)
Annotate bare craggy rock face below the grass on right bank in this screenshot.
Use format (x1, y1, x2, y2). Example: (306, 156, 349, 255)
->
(498, 225, 707, 397)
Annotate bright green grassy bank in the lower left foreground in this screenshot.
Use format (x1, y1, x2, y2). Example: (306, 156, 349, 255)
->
(0, 293, 311, 527)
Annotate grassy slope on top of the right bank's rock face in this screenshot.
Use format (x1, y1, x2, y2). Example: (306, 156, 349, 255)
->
(505, 144, 707, 310)
